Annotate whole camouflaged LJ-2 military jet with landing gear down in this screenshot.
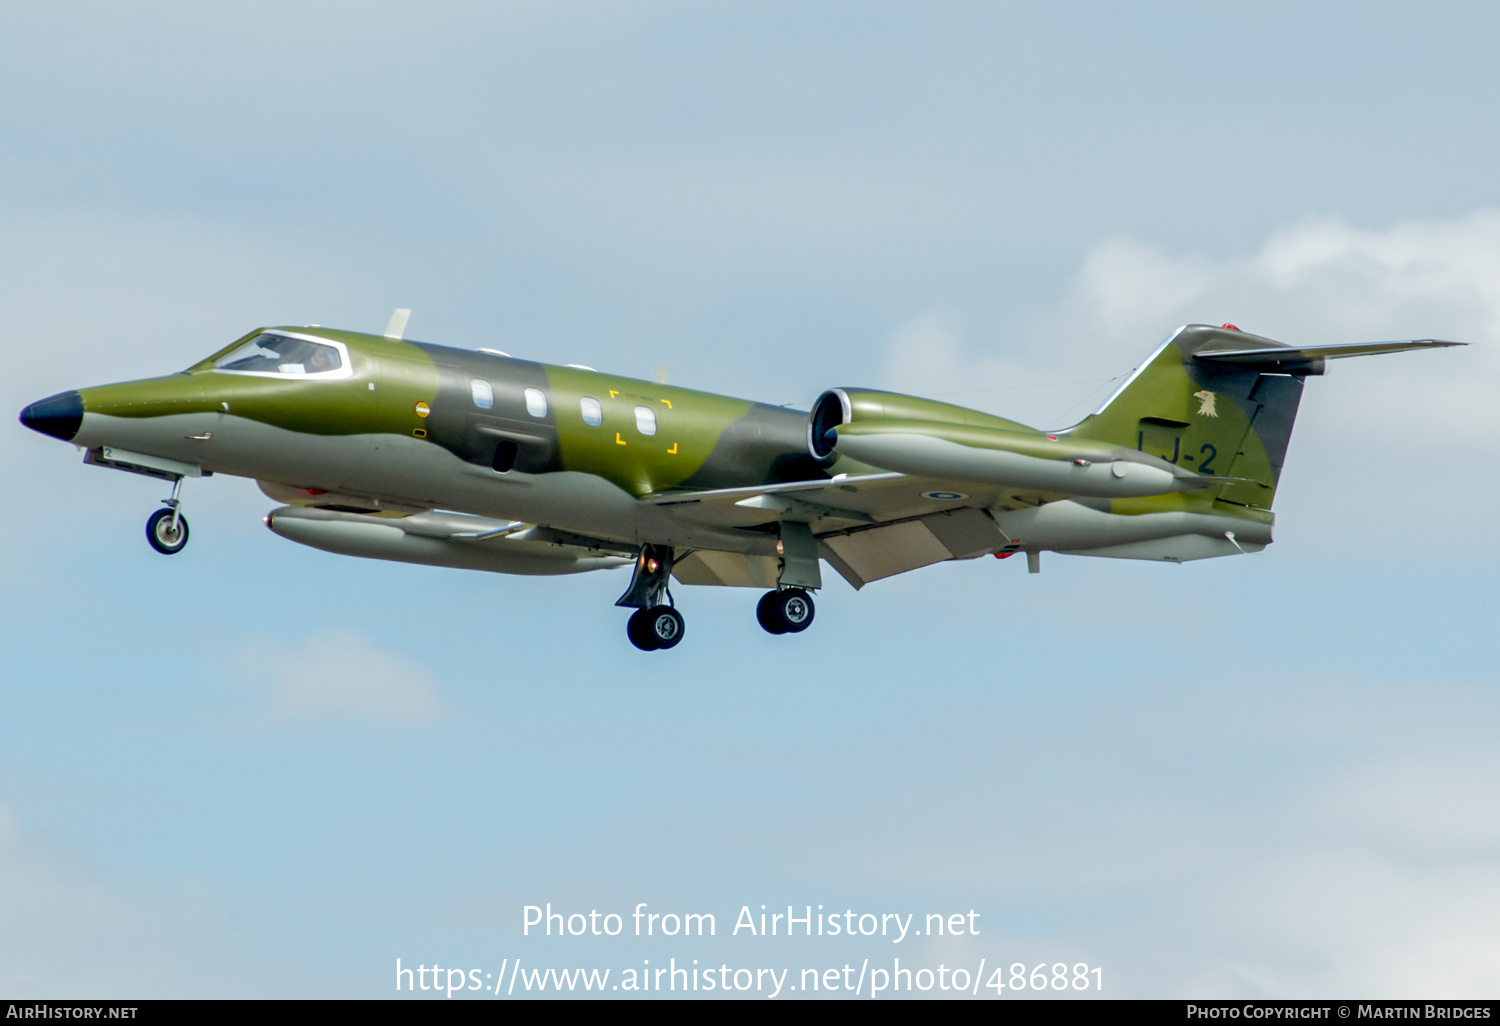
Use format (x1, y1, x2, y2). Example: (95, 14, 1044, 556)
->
(21, 311, 1460, 651)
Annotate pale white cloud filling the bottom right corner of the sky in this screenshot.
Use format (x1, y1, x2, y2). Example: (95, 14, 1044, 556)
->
(1160, 678, 1500, 998)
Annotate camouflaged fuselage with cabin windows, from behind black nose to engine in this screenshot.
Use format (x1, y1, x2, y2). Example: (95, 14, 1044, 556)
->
(38, 329, 828, 551)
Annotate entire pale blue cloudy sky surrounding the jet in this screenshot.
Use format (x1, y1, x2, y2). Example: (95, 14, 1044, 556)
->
(0, 2, 1500, 1001)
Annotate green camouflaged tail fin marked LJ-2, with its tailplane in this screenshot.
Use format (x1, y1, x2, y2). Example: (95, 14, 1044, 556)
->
(1061, 324, 1461, 510)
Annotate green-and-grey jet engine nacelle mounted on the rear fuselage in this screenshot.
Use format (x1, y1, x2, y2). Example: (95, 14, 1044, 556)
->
(807, 389, 1226, 498)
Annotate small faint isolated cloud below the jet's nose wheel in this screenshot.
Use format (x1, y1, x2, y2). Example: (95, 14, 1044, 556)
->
(239, 632, 441, 723)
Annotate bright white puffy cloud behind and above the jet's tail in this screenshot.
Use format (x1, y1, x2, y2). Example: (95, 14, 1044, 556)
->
(885, 210, 1500, 429)
